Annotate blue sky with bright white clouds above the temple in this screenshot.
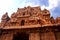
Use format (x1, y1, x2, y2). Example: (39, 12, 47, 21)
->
(0, 0, 60, 21)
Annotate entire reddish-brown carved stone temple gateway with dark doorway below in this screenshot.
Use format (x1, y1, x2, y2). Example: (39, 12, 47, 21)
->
(0, 6, 60, 40)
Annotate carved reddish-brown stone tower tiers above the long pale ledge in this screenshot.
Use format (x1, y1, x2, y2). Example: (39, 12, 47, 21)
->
(1, 6, 60, 26)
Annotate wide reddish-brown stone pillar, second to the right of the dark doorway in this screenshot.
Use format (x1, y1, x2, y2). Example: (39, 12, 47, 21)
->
(41, 32, 56, 40)
